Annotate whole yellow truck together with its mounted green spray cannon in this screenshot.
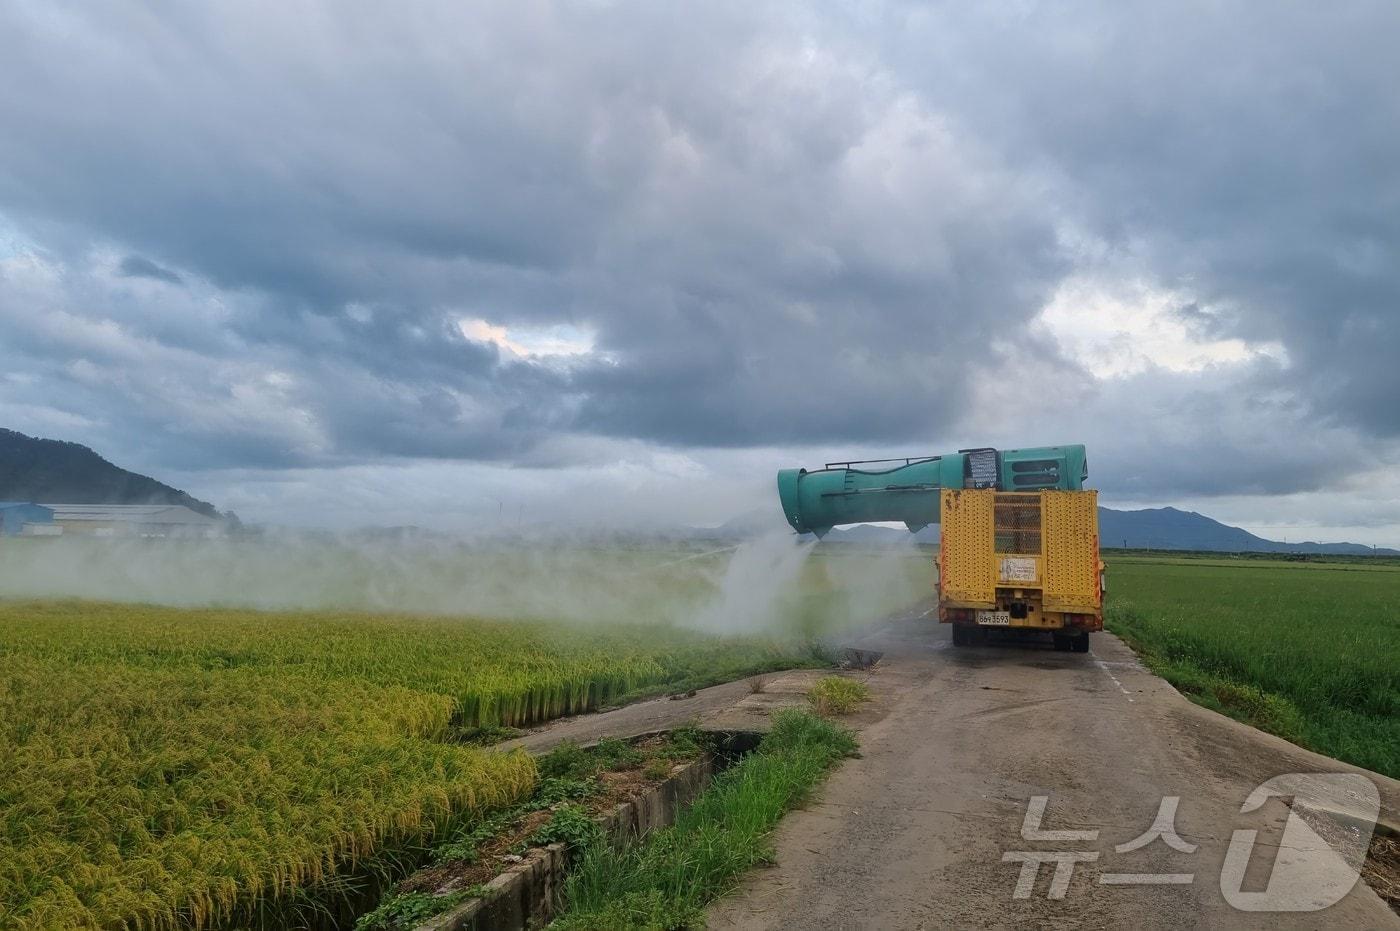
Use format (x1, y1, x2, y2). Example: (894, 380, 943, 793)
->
(778, 445, 1103, 652)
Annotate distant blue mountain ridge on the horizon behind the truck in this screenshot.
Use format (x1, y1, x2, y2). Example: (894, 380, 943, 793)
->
(728, 507, 1400, 556)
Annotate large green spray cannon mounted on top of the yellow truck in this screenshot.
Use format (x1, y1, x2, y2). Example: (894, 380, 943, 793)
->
(778, 445, 1089, 536)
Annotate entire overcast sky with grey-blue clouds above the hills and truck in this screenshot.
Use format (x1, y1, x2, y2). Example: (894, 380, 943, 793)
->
(0, 0, 1400, 545)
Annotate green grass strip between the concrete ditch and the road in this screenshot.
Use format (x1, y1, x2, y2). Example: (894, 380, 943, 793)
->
(552, 710, 855, 931)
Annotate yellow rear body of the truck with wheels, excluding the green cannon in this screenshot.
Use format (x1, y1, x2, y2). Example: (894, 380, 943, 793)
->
(938, 489, 1105, 652)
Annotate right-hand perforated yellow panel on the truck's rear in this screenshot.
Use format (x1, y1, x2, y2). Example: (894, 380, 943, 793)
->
(1040, 491, 1099, 612)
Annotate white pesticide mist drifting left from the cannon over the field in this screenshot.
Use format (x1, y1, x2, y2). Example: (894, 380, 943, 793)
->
(0, 533, 931, 637)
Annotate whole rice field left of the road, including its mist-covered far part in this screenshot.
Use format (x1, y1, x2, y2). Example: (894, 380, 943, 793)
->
(0, 536, 931, 931)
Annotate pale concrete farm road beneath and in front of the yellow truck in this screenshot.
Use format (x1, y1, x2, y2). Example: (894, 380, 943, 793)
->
(710, 607, 1400, 930)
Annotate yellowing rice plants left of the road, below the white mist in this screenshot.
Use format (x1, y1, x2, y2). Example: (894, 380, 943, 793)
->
(0, 602, 812, 930)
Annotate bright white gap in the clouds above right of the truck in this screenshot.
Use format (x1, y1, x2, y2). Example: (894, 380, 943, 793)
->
(1036, 277, 1288, 378)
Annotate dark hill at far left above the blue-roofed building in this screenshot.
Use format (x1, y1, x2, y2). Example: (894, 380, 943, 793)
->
(0, 427, 220, 518)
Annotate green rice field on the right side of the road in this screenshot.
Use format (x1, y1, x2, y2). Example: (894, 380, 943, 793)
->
(1106, 554, 1400, 778)
